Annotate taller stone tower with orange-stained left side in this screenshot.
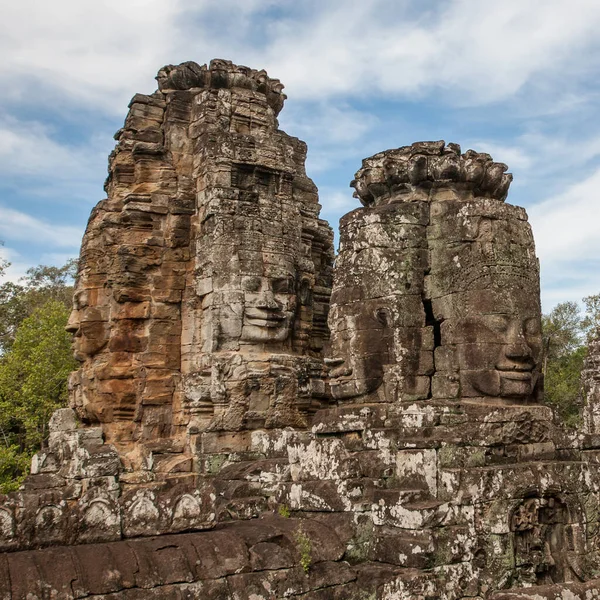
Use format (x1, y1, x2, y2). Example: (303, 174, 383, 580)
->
(69, 60, 333, 470)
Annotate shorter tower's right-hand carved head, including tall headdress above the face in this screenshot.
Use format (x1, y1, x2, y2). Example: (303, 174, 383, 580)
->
(428, 197, 542, 403)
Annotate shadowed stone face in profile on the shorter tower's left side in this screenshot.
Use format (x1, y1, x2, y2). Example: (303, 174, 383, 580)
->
(326, 299, 392, 399)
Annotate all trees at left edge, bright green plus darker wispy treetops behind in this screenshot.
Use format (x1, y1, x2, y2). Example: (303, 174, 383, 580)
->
(0, 255, 77, 492)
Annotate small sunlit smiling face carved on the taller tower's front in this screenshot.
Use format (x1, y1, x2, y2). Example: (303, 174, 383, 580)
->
(241, 272, 296, 343)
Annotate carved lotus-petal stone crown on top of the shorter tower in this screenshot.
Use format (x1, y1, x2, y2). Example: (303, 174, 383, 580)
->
(350, 141, 512, 206)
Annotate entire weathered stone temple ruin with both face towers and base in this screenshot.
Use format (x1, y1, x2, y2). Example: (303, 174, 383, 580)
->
(0, 60, 600, 600)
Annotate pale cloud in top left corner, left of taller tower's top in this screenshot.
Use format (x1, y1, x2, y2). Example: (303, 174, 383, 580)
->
(0, 0, 185, 112)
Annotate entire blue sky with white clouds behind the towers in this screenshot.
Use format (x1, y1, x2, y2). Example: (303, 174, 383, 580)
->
(0, 0, 600, 311)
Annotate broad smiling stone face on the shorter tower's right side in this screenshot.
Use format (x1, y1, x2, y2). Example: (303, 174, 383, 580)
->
(450, 289, 542, 400)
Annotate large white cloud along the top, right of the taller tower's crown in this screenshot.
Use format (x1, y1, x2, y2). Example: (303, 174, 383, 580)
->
(265, 0, 600, 105)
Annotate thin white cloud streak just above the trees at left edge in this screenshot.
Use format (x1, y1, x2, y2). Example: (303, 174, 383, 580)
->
(0, 206, 83, 249)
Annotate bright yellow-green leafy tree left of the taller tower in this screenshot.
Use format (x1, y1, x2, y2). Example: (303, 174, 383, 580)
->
(0, 299, 77, 491)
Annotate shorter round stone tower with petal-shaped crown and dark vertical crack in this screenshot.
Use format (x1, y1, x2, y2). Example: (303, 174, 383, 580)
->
(330, 142, 541, 403)
